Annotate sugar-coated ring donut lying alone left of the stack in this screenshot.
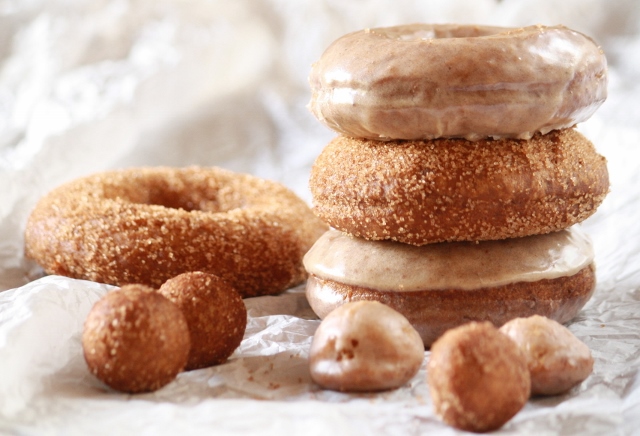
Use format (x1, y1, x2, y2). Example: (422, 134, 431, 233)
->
(25, 167, 326, 297)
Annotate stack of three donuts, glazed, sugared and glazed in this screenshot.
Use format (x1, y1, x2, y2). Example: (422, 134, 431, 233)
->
(304, 24, 609, 347)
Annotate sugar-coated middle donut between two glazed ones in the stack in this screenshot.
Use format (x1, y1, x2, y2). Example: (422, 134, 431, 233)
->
(310, 129, 609, 245)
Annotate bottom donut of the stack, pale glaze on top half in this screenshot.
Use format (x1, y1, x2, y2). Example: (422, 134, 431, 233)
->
(304, 227, 596, 347)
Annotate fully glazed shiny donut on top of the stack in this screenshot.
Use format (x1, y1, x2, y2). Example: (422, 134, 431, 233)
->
(309, 24, 607, 140)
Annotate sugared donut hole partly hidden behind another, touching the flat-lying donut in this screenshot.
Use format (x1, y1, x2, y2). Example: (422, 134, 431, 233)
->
(158, 271, 247, 371)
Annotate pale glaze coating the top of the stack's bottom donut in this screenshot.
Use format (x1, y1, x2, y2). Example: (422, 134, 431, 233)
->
(304, 226, 594, 291)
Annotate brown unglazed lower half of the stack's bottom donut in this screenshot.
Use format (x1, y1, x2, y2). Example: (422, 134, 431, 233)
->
(306, 264, 596, 347)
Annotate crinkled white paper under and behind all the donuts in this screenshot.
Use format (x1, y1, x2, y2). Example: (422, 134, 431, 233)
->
(0, 0, 640, 435)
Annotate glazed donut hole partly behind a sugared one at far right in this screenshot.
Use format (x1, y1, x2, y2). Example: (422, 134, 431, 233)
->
(500, 315, 593, 395)
